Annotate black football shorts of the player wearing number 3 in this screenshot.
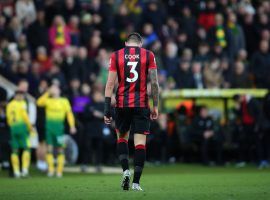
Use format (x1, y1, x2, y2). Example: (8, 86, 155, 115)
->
(115, 108, 150, 135)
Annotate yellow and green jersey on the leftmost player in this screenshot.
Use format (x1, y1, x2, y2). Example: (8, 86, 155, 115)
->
(6, 99, 31, 134)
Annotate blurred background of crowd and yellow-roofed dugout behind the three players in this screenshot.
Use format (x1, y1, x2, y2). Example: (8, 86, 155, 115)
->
(0, 0, 270, 171)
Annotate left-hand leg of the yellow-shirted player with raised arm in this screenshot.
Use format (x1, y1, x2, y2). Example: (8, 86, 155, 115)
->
(46, 132, 54, 177)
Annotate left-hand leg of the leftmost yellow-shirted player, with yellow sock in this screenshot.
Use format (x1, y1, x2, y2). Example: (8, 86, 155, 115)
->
(10, 133, 21, 178)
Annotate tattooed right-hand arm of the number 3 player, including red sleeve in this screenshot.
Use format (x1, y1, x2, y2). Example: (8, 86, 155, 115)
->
(149, 52, 159, 120)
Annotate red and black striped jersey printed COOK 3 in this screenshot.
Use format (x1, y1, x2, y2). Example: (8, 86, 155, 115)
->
(109, 46, 157, 108)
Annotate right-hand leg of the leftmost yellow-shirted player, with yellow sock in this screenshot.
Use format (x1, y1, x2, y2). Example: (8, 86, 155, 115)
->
(21, 133, 31, 177)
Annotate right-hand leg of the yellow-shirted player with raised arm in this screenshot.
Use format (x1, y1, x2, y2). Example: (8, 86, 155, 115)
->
(55, 133, 65, 178)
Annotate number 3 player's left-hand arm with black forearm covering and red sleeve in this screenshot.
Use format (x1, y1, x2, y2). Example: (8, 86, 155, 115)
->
(104, 53, 117, 124)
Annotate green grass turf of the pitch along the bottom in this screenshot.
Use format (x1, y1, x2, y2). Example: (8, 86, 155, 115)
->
(0, 165, 270, 200)
